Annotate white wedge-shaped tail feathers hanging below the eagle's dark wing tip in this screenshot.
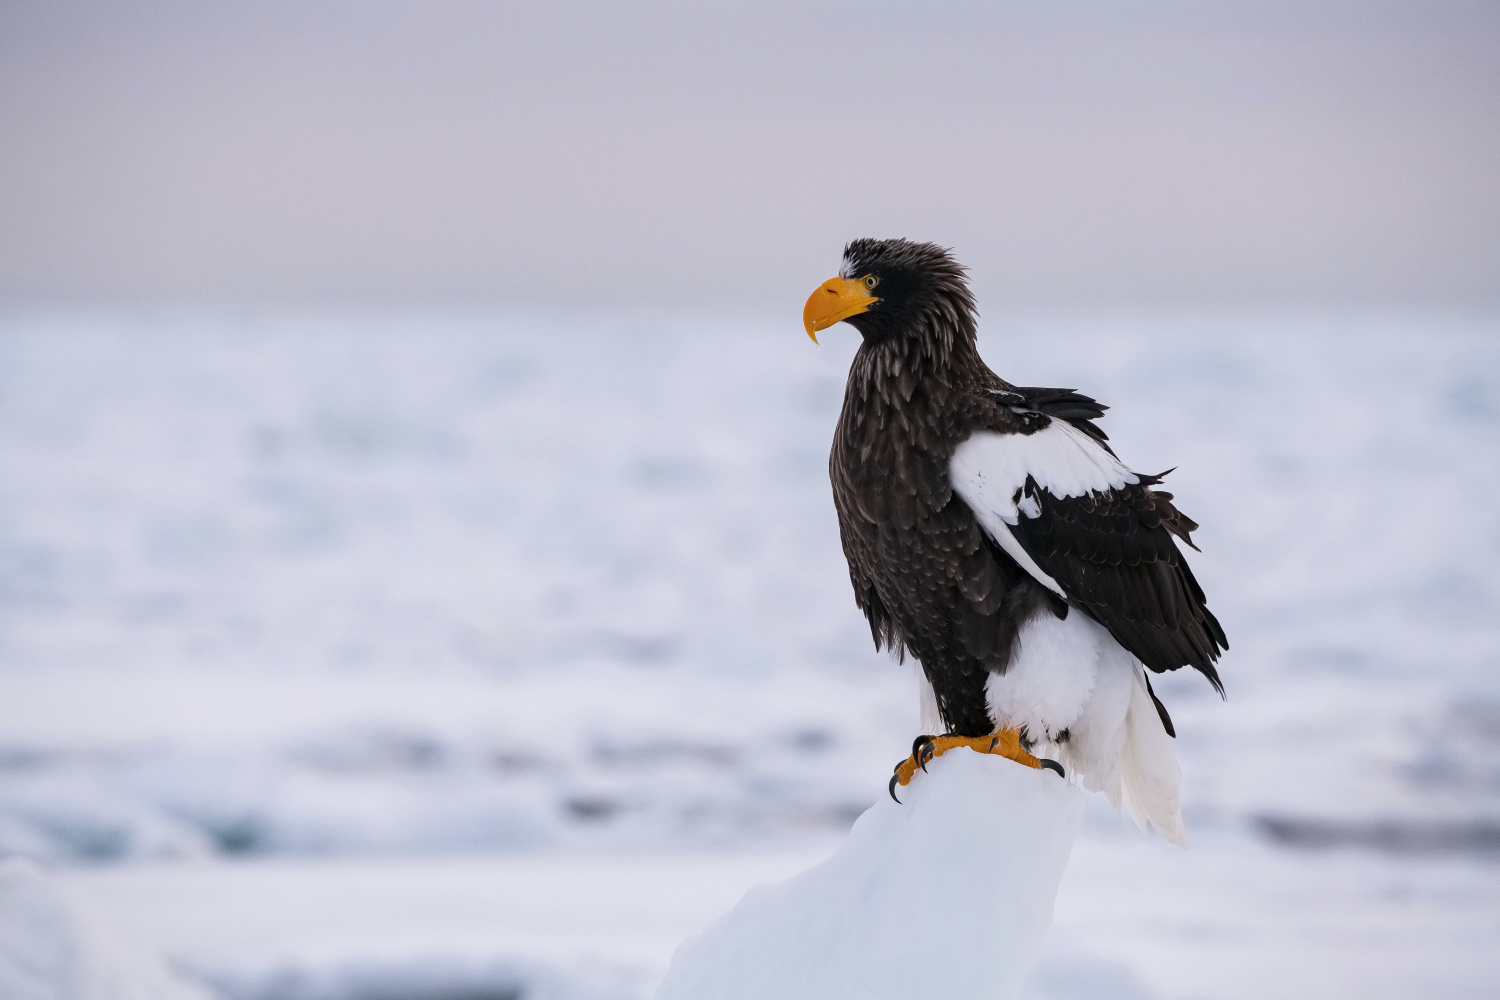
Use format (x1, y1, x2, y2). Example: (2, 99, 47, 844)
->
(1104, 667, 1188, 847)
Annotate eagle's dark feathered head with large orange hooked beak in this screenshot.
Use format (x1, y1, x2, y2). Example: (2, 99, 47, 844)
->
(803, 240, 975, 350)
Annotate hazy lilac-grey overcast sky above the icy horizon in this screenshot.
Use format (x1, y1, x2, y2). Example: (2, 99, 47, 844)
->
(0, 0, 1500, 309)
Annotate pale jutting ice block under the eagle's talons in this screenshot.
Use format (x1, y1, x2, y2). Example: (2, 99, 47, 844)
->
(656, 750, 1085, 1000)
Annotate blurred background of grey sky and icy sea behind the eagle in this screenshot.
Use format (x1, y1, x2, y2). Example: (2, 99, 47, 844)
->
(0, 0, 1500, 1000)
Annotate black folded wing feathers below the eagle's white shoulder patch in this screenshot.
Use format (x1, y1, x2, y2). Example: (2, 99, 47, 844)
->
(1011, 475, 1229, 694)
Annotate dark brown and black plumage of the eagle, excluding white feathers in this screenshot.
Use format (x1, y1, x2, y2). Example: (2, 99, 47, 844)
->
(828, 240, 1229, 736)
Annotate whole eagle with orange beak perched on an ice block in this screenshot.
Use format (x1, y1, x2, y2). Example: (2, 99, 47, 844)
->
(803, 240, 1229, 844)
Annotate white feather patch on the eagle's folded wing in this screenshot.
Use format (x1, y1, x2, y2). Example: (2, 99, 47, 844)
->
(948, 420, 1140, 597)
